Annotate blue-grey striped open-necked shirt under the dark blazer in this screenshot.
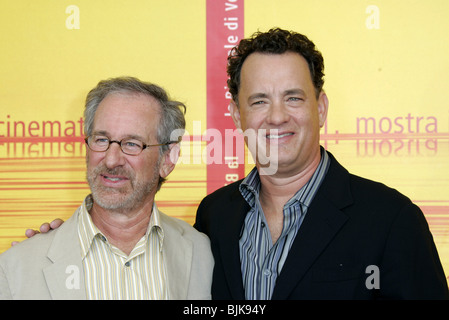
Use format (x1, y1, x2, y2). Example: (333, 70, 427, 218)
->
(239, 149, 329, 300)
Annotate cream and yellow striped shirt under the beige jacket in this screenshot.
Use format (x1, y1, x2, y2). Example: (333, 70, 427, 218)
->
(78, 196, 169, 300)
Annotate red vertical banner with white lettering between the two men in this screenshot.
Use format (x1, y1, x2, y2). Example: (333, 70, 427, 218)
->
(205, 0, 245, 194)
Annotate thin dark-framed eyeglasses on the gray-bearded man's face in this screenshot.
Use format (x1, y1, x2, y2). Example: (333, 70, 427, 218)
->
(84, 135, 179, 156)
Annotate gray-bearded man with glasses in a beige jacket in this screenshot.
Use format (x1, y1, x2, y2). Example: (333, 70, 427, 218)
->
(0, 77, 213, 299)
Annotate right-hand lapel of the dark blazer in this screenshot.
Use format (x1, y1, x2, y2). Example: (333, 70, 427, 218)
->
(272, 153, 352, 299)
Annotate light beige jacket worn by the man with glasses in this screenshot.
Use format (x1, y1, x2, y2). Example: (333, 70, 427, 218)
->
(0, 210, 214, 300)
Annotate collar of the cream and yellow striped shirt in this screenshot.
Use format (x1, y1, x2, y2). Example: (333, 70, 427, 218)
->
(78, 195, 164, 259)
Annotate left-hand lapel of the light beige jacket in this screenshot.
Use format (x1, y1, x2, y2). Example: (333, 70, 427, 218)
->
(43, 213, 86, 300)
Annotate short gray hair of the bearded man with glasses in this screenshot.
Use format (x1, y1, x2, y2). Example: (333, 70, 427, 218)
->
(84, 77, 186, 190)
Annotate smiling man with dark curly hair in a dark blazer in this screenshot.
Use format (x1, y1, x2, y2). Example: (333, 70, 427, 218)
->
(195, 29, 449, 299)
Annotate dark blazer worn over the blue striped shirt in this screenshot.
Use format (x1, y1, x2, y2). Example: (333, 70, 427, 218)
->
(195, 153, 449, 300)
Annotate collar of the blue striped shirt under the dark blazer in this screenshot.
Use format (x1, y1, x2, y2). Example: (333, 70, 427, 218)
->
(239, 147, 330, 208)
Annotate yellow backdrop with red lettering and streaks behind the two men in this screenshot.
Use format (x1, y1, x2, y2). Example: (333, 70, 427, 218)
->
(0, 0, 449, 275)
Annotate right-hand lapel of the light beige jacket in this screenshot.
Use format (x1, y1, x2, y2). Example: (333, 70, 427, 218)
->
(159, 211, 193, 300)
